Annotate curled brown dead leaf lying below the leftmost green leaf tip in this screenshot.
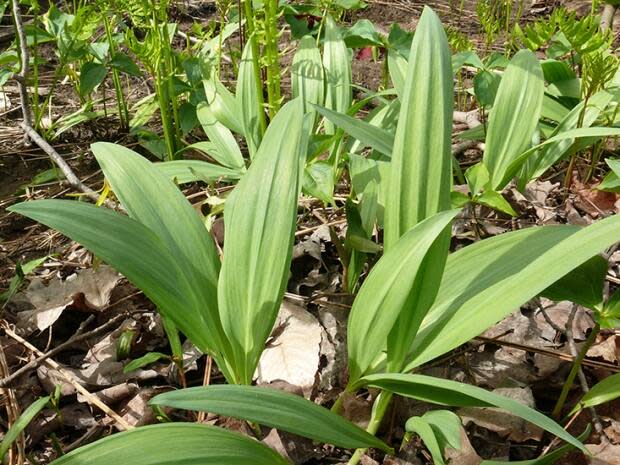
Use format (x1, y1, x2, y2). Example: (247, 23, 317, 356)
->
(17, 265, 121, 335)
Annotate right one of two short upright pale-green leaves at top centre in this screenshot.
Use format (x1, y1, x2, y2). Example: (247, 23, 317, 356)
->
(323, 15, 351, 134)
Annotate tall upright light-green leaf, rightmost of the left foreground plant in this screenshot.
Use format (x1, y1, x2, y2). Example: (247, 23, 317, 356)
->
(218, 99, 306, 384)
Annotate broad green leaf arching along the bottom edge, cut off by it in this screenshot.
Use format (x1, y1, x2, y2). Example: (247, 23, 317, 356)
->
(51, 423, 290, 465)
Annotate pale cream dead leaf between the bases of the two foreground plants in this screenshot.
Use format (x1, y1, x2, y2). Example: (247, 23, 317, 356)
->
(254, 301, 324, 398)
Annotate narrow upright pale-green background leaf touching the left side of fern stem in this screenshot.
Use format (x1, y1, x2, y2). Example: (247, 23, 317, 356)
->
(236, 36, 263, 158)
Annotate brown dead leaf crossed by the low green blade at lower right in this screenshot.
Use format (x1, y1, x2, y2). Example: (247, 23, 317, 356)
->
(458, 387, 543, 442)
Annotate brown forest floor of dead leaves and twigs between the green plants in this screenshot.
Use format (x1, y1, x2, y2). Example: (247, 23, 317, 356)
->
(0, 0, 620, 465)
